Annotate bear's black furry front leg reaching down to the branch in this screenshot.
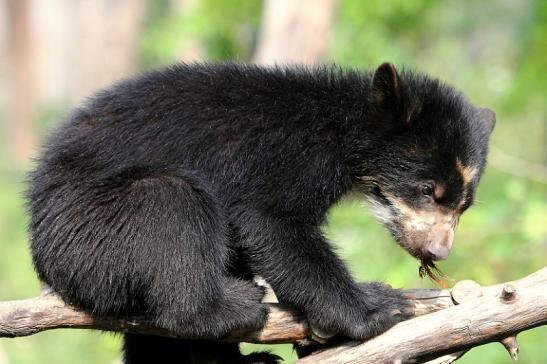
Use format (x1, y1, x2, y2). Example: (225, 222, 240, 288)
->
(240, 215, 412, 339)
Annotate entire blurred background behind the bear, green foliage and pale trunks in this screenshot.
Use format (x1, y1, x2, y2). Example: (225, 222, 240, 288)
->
(0, 0, 547, 364)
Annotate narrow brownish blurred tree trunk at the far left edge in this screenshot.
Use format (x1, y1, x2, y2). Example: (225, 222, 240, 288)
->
(7, 0, 36, 164)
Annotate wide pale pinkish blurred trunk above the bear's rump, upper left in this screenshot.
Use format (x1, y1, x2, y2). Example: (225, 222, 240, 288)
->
(65, 0, 146, 101)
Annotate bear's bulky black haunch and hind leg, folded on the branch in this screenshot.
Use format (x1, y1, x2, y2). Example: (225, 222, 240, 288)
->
(31, 167, 266, 338)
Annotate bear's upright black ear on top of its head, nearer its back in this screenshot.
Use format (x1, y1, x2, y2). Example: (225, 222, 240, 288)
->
(371, 62, 413, 124)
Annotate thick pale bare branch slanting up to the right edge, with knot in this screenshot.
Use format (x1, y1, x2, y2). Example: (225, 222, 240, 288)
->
(298, 268, 547, 364)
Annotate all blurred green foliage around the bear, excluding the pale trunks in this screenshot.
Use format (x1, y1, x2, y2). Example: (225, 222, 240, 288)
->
(0, 0, 547, 364)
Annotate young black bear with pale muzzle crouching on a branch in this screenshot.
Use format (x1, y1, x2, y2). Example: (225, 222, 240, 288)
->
(28, 63, 495, 363)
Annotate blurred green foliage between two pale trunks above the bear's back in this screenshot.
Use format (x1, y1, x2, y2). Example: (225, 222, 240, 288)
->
(140, 0, 262, 68)
